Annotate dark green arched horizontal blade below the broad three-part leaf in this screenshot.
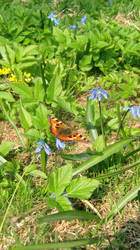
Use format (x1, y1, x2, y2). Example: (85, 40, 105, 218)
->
(38, 210, 99, 224)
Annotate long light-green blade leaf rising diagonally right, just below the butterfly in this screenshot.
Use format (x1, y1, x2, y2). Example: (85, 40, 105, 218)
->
(73, 139, 132, 176)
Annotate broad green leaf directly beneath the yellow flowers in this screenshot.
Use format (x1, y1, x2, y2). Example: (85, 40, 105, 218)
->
(10, 83, 33, 100)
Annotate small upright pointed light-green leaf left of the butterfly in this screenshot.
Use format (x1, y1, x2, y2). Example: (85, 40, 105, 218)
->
(19, 105, 32, 131)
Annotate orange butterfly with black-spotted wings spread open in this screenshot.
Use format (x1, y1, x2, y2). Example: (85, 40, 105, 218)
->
(48, 116, 88, 142)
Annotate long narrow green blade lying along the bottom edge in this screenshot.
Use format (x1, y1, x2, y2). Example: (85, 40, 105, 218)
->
(13, 238, 97, 250)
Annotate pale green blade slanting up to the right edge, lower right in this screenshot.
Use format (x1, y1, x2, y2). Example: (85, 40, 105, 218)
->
(107, 184, 140, 221)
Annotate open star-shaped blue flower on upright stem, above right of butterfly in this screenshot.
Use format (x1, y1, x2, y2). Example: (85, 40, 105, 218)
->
(87, 87, 108, 101)
